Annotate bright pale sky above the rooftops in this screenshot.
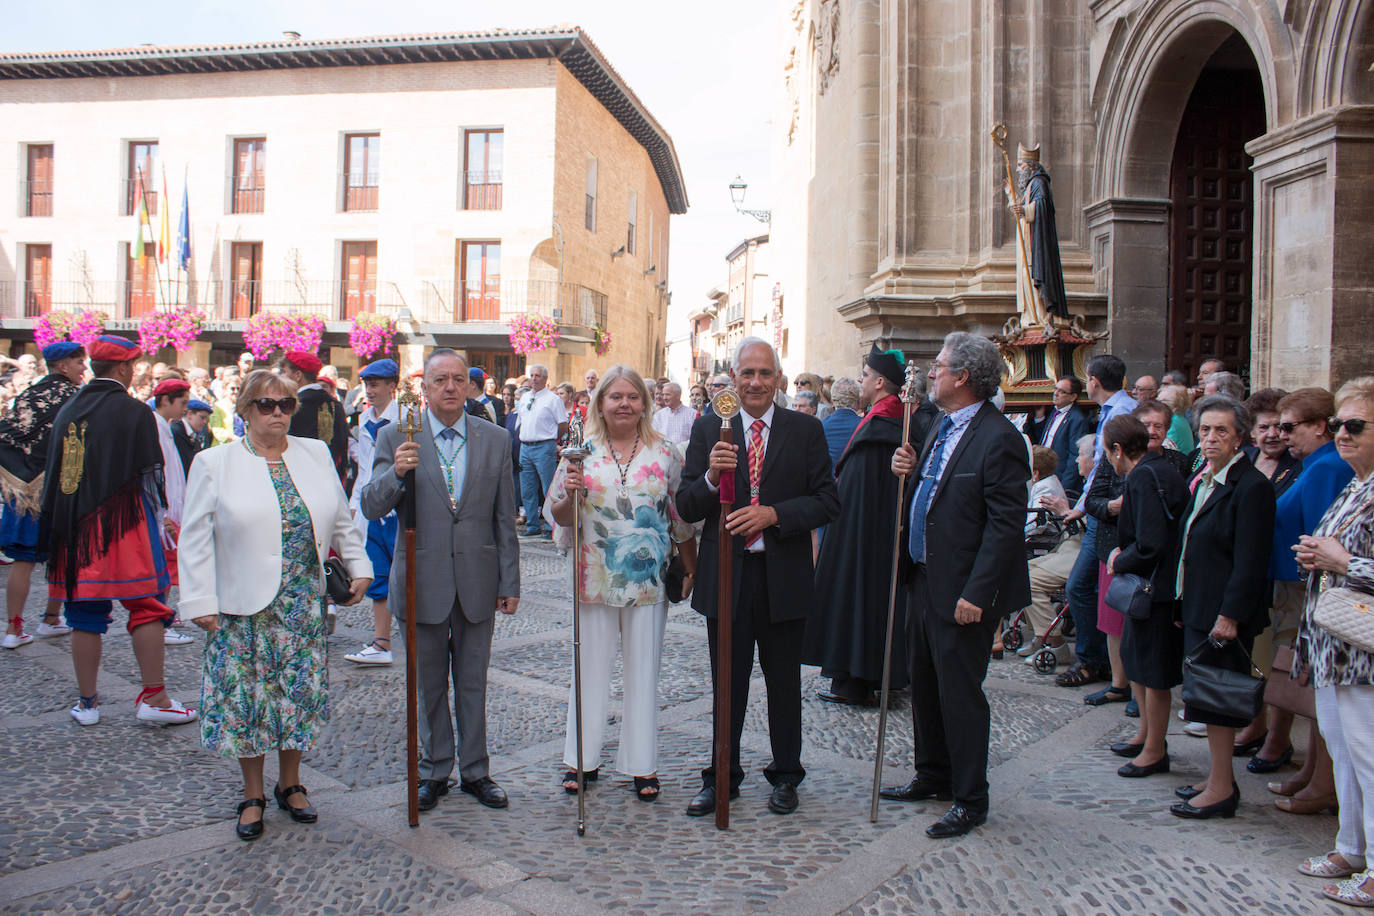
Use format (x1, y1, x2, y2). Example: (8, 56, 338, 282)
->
(0, 0, 786, 339)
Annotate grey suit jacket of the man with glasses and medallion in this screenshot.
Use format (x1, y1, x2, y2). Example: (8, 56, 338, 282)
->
(361, 416, 519, 623)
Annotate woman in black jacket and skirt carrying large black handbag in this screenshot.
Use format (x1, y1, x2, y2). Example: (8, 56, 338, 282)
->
(1169, 396, 1274, 818)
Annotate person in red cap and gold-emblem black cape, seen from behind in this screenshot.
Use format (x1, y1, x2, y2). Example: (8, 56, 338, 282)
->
(40, 336, 196, 725)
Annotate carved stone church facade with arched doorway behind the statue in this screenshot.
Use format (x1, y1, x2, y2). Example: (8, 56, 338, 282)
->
(772, 0, 1374, 387)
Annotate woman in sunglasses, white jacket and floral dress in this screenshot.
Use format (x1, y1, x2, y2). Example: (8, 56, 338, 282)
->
(180, 369, 372, 840)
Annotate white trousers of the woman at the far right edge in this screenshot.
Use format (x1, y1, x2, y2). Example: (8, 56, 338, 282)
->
(1316, 687, 1374, 865)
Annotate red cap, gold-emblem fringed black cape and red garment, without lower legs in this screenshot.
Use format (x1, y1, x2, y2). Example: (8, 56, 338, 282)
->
(40, 336, 173, 633)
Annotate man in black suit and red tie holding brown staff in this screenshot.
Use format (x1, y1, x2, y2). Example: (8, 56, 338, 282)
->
(677, 338, 835, 817)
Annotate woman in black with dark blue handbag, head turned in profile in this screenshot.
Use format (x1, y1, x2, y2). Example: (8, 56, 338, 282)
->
(1102, 414, 1189, 777)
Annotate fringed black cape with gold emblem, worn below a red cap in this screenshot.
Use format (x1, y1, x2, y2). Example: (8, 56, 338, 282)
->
(38, 379, 166, 595)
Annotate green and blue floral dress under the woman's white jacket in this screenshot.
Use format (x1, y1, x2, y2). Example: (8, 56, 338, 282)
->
(201, 461, 330, 757)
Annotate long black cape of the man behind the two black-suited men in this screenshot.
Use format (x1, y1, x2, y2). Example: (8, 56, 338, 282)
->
(801, 411, 929, 689)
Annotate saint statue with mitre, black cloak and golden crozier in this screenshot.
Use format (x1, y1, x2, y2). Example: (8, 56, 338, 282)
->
(1006, 144, 1069, 327)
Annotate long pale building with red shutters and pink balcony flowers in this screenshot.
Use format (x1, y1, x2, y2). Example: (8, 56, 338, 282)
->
(0, 27, 687, 380)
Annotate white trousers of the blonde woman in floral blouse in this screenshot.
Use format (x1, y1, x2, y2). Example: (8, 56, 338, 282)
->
(563, 602, 668, 776)
